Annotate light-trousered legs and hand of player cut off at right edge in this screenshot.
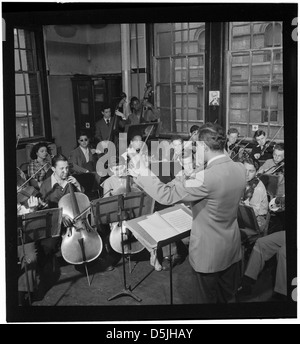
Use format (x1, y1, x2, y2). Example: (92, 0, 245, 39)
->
(238, 199, 287, 301)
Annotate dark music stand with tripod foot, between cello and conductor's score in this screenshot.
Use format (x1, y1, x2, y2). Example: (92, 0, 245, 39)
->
(91, 192, 154, 302)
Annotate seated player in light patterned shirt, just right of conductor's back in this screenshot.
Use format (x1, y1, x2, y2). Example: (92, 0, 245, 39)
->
(242, 158, 269, 228)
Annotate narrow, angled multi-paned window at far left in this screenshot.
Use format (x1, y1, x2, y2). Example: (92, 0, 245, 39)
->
(14, 28, 45, 139)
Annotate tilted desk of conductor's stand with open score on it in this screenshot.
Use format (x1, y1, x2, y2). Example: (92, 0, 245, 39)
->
(125, 204, 193, 252)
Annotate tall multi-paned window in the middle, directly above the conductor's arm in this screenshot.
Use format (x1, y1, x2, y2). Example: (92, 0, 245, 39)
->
(154, 23, 205, 134)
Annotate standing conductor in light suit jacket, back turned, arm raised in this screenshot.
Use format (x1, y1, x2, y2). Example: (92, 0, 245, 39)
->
(130, 128, 246, 303)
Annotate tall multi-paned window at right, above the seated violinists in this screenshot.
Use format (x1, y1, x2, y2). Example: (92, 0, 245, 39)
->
(227, 22, 283, 139)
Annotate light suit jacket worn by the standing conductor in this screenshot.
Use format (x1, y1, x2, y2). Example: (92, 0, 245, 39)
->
(135, 156, 246, 273)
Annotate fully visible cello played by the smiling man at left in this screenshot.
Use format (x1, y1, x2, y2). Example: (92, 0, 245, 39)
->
(58, 183, 103, 267)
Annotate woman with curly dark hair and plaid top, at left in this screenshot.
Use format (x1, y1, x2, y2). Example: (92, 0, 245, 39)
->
(28, 142, 52, 189)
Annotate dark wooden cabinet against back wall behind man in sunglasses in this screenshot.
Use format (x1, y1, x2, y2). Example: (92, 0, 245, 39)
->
(71, 74, 122, 144)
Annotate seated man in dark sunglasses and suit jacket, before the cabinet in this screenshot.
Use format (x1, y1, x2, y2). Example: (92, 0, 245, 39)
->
(68, 132, 100, 198)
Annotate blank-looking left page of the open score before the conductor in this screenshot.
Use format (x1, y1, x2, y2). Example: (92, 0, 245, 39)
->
(138, 213, 176, 242)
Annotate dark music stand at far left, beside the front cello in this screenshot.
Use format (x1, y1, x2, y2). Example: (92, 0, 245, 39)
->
(18, 208, 62, 306)
